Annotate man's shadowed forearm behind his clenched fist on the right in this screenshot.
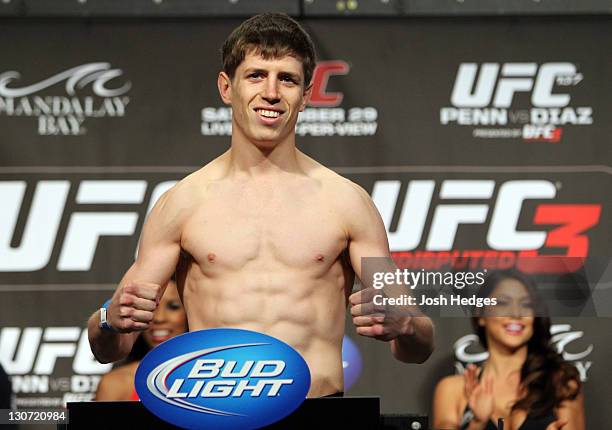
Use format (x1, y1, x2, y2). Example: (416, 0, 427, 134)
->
(391, 316, 434, 363)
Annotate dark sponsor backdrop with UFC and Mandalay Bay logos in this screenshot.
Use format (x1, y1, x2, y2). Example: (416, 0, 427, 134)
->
(0, 17, 612, 428)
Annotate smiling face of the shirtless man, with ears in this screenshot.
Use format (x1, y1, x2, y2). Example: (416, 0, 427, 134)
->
(218, 51, 310, 148)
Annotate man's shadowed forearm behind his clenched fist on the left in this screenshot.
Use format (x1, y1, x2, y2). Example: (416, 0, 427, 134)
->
(87, 310, 138, 363)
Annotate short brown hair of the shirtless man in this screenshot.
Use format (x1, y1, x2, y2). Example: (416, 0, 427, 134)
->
(221, 13, 316, 87)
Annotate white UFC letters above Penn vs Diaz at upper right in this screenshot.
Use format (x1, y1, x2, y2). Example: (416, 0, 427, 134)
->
(451, 63, 582, 108)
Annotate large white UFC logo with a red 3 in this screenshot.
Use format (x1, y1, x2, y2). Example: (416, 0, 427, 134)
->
(372, 179, 601, 255)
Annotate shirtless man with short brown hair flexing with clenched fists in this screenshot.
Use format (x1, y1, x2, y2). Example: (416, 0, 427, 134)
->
(89, 14, 433, 397)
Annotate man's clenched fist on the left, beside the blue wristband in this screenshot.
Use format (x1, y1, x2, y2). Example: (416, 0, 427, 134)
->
(106, 281, 163, 333)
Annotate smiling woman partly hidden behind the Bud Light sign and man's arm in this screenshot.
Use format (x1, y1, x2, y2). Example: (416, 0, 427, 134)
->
(96, 281, 188, 401)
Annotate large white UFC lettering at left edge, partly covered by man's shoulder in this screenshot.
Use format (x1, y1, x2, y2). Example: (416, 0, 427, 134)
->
(0, 180, 176, 272)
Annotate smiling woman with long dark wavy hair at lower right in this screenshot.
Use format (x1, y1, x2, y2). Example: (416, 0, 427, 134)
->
(433, 272, 584, 430)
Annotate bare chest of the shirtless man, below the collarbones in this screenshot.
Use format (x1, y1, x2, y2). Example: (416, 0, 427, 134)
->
(182, 183, 346, 275)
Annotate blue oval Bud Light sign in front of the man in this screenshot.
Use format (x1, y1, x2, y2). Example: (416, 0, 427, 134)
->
(136, 328, 310, 430)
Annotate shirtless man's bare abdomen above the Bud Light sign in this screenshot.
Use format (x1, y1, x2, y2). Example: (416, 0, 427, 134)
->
(179, 259, 352, 397)
